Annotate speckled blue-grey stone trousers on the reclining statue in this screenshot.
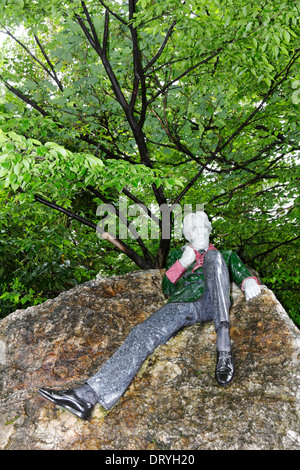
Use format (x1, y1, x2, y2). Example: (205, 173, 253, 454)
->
(86, 250, 230, 409)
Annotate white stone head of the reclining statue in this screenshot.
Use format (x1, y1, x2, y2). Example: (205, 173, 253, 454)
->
(183, 211, 212, 250)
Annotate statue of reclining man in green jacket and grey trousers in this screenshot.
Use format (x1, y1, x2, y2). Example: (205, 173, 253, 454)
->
(39, 212, 260, 419)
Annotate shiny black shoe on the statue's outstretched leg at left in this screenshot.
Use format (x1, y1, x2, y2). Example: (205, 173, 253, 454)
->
(38, 388, 94, 420)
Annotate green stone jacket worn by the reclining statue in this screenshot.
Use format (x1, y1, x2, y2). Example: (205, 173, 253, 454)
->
(162, 250, 252, 302)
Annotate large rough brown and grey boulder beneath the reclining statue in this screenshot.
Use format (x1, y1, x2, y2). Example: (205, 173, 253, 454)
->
(0, 271, 300, 451)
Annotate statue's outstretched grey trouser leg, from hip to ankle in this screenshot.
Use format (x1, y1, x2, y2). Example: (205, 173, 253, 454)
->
(86, 303, 197, 409)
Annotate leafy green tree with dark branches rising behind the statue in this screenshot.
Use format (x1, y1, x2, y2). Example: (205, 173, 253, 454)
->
(0, 0, 300, 322)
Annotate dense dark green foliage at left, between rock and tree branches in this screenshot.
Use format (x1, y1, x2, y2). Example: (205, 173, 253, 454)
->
(0, 190, 137, 318)
